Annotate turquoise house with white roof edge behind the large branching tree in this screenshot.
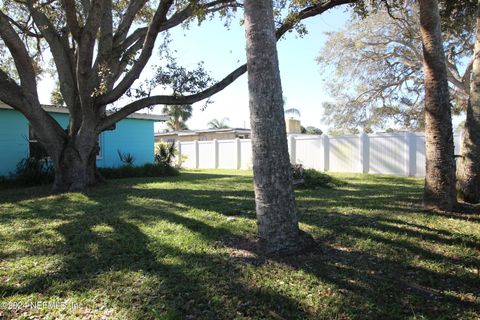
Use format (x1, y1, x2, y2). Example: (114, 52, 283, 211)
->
(0, 103, 168, 176)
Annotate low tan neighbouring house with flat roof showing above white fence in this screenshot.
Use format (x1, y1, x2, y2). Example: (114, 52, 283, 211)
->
(155, 128, 251, 142)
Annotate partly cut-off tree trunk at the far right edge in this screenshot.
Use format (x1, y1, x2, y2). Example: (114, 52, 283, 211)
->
(457, 1, 480, 203)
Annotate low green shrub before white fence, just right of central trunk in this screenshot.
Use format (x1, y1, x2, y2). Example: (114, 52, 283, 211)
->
(292, 164, 346, 189)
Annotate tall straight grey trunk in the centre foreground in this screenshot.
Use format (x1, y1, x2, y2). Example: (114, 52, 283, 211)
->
(244, 0, 308, 253)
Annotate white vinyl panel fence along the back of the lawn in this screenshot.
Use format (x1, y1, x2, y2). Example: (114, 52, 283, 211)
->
(177, 132, 460, 176)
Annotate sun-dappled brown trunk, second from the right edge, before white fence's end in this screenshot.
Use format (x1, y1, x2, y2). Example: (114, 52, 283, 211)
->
(419, 0, 456, 211)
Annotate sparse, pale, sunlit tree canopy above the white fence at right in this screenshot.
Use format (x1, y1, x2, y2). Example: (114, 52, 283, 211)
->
(318, 1, 473, 132)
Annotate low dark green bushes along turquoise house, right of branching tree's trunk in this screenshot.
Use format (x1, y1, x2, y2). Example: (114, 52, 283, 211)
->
(98, 163, 180, 179)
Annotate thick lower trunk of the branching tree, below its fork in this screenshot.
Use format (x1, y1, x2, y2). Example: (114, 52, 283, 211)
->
(53, 135, 103, 192)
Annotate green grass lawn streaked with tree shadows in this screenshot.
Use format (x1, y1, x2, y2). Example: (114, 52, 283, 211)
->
(0, 171, 480, 319)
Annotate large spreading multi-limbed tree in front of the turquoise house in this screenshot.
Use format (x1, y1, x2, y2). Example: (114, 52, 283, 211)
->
(0, 0, 355, 191)
